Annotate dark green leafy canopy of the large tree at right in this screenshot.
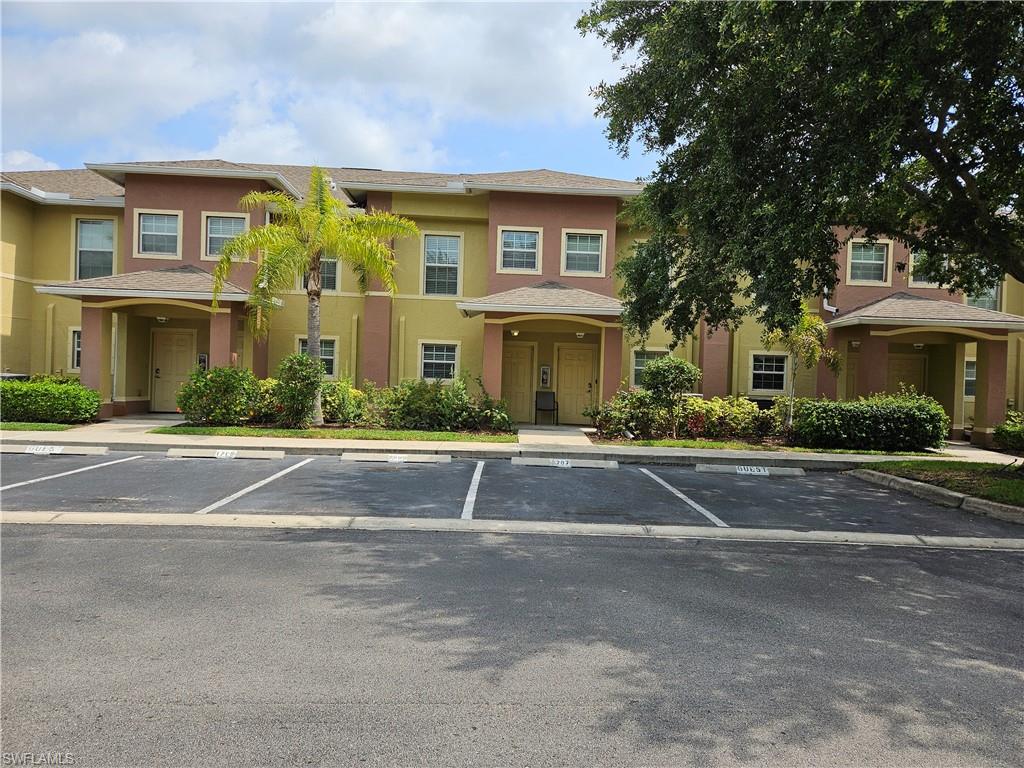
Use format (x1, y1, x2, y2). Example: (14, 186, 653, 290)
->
(579, 0, 1024, 338)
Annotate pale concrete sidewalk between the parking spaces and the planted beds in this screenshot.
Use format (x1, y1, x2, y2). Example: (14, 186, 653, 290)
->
(0, 416, 1014, 471)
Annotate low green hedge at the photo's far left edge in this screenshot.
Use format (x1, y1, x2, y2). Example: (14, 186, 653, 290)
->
(0, 379, 101, 424)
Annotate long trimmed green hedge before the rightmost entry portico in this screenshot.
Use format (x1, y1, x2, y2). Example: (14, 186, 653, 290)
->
(791, 390, 949, 451)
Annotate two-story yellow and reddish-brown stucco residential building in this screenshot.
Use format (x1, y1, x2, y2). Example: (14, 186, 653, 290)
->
(0, 160, 1024, 441)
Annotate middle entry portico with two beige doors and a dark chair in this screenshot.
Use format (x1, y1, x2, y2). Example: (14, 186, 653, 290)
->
(457, 281, 623, 424)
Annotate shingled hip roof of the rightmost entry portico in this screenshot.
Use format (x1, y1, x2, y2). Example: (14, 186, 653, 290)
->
(826, 291, 1024, 331)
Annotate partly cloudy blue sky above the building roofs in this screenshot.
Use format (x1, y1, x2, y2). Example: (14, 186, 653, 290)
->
(2, 2, 653, 179)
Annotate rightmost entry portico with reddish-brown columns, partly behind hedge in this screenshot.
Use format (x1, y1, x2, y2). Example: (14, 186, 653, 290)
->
(818, 292, 1024, 445)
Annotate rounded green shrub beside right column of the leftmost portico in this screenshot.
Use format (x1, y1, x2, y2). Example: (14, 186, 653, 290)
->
(177, 367, 259, 427)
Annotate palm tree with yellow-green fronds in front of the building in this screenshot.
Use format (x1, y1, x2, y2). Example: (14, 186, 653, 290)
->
(213, 166, 419, 425)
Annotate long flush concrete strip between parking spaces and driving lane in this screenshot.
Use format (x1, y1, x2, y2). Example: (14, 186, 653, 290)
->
(0, 511, 1024, 552)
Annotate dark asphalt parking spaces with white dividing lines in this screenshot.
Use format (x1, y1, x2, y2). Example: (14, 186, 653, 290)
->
(0, 453, 1021, 538)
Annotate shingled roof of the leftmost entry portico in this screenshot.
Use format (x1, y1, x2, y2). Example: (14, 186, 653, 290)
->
(36, 264, 249, 301)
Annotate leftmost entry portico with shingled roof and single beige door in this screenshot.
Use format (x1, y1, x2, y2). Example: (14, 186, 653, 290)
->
(36, 265, 256, 418)
